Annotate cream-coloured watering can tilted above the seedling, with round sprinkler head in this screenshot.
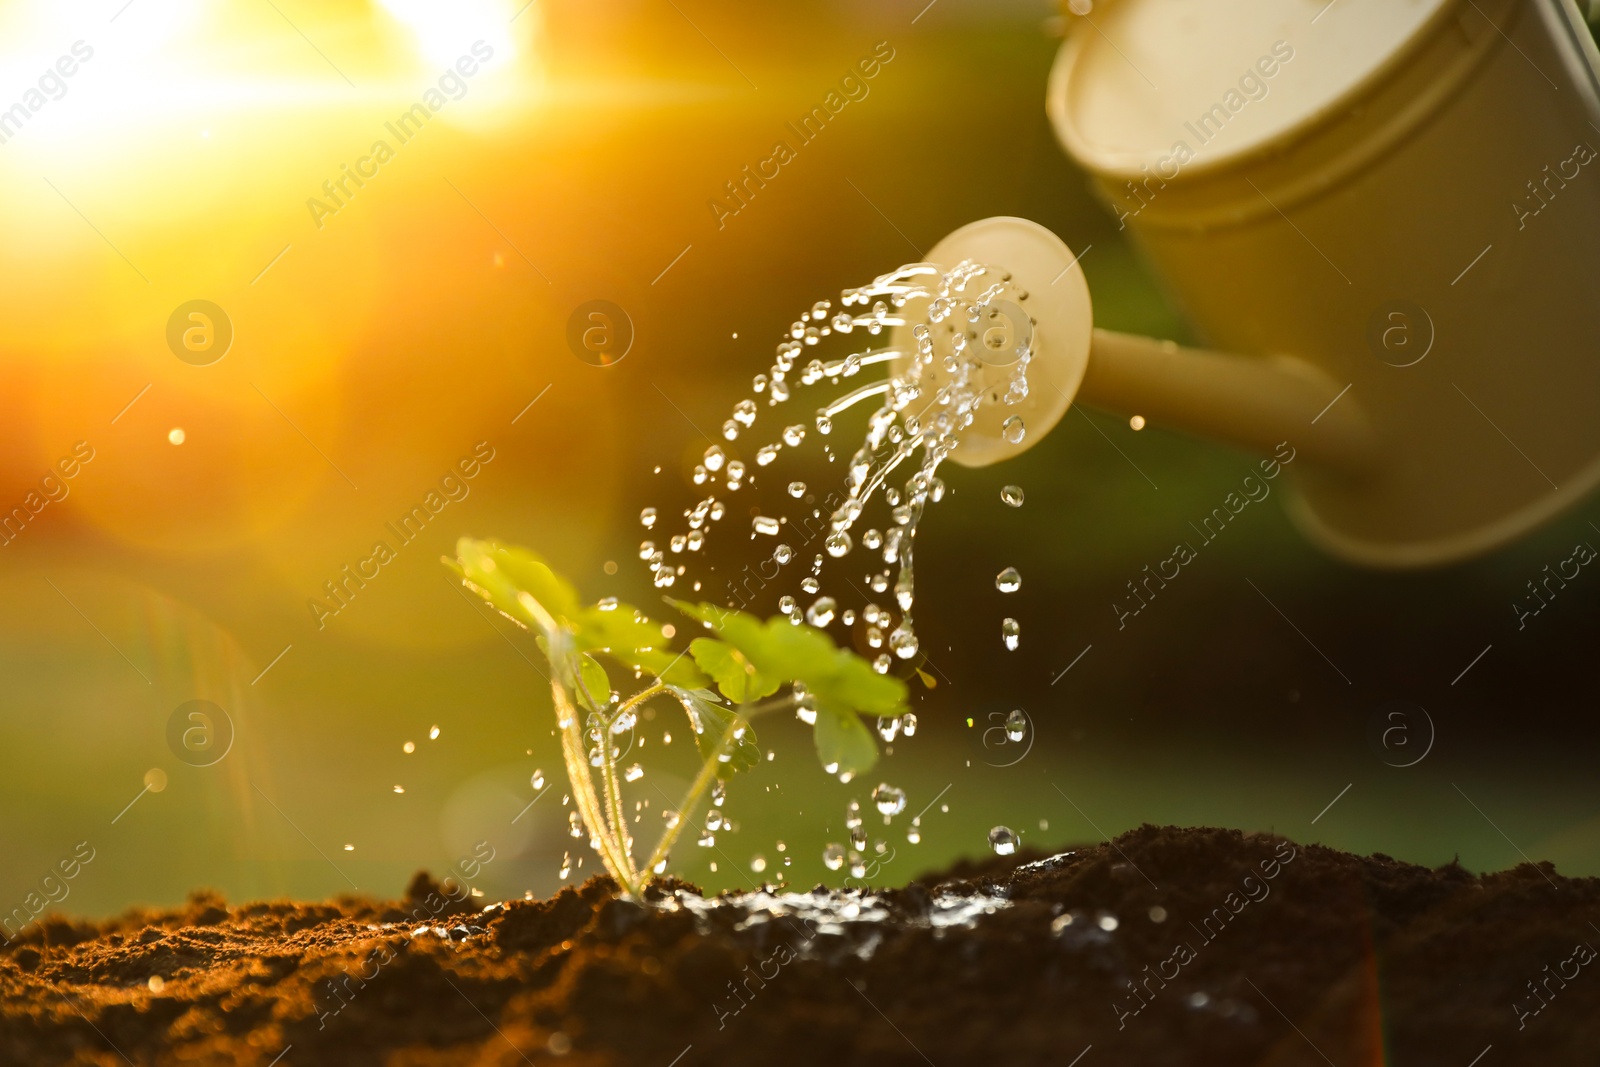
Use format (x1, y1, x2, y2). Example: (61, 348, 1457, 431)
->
(899, 0, 1600, 568)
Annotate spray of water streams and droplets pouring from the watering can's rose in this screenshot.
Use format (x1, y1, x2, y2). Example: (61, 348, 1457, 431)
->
(640, 261, 1032, 659)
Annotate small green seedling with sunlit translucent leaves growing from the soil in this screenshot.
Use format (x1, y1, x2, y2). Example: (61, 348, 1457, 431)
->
(445, 537, 907, 896)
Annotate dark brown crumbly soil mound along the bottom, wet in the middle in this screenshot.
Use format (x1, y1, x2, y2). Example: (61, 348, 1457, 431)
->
(0, 827, 1600, 1067)
